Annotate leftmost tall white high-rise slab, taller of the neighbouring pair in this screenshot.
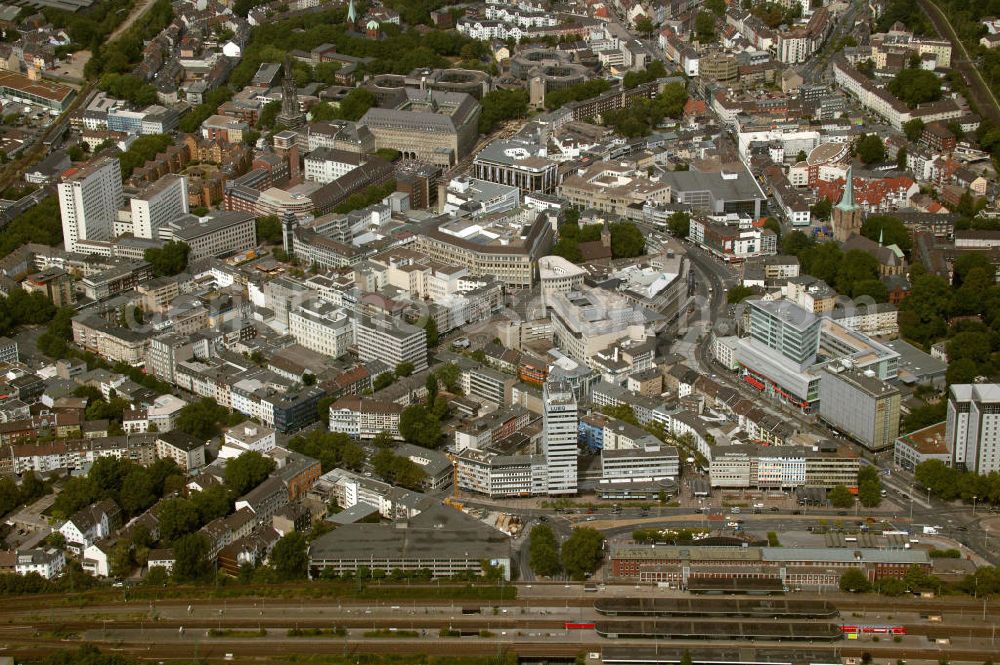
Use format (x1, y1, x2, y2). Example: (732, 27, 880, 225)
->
(59, 157, 124, 252)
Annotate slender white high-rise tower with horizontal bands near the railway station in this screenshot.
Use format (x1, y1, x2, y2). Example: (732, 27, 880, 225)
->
(542, 381, 579, 495)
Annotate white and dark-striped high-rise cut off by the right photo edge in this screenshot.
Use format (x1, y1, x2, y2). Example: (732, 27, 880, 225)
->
(945, 383, 1000, 473)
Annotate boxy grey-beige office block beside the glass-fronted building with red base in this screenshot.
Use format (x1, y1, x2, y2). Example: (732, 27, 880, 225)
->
(819, 363, 900, 451)
